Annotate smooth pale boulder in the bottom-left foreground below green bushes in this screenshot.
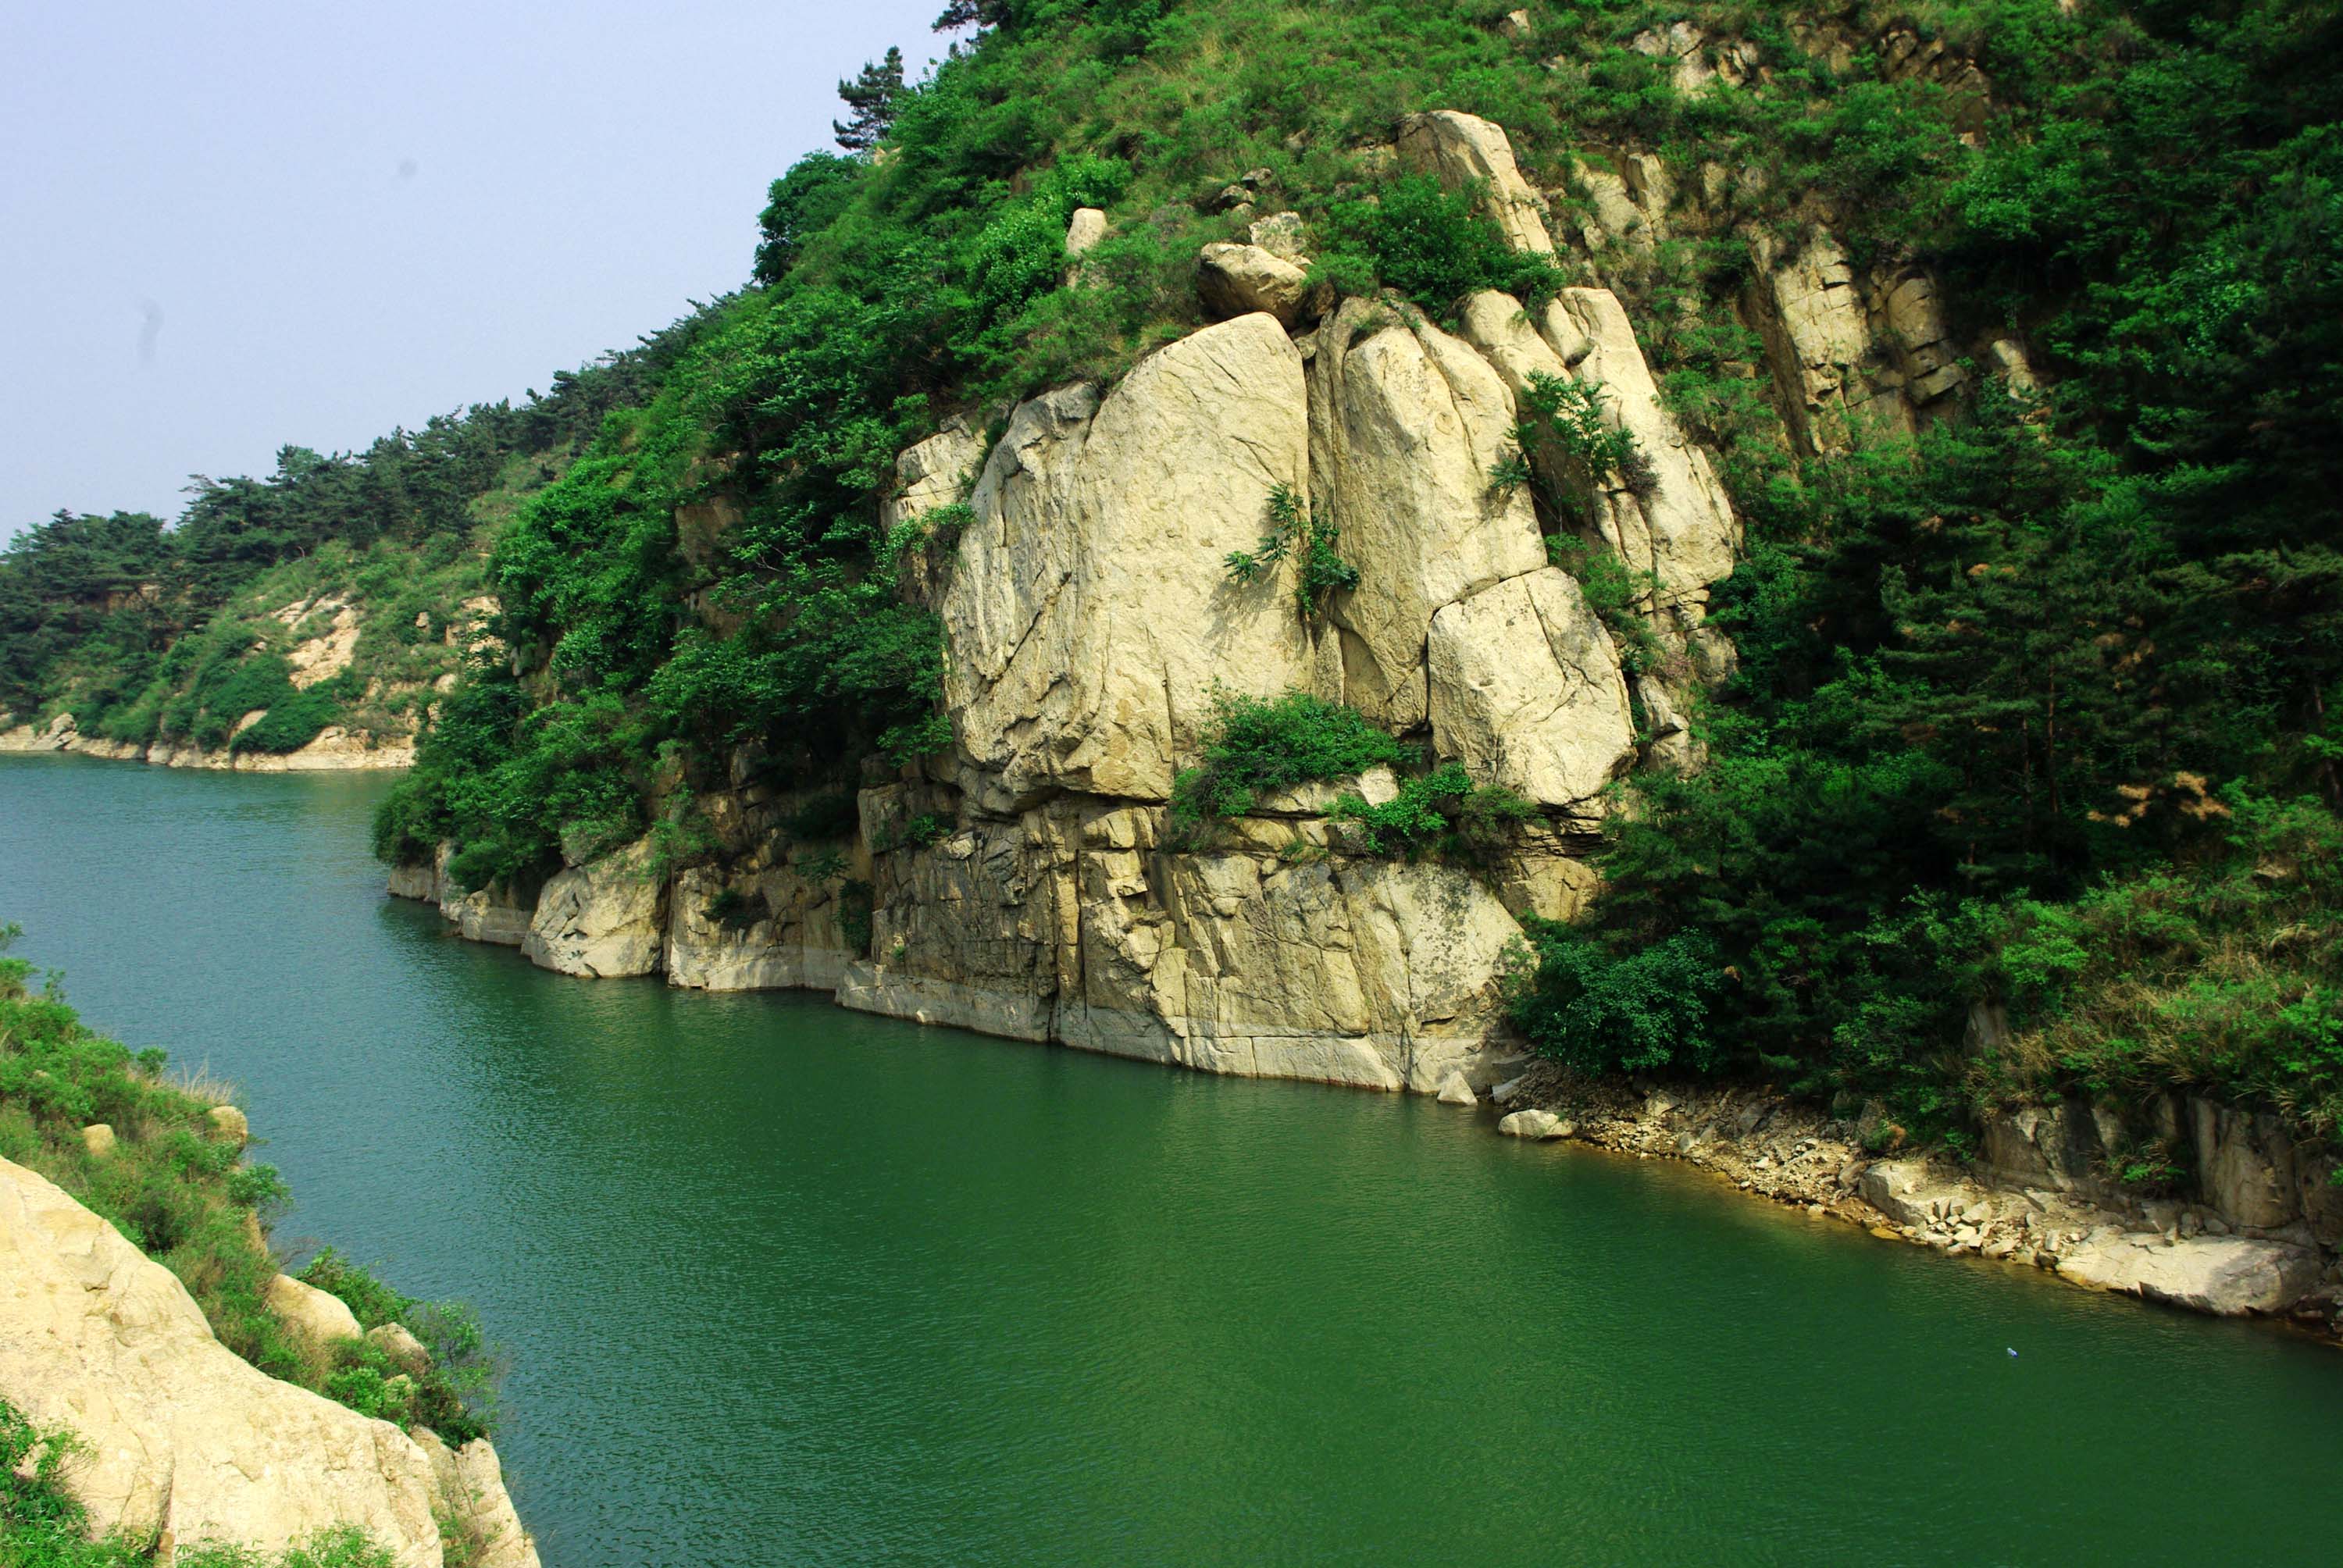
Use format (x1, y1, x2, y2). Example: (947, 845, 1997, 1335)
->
(0, 1160, 440, 1568)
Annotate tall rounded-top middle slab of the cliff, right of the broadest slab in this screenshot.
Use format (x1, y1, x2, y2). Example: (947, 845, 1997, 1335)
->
(1310, 300, 1546, 731)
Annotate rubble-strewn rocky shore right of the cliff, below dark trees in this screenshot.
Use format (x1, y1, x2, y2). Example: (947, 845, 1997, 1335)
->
(1490, 1064, 2343, 1341)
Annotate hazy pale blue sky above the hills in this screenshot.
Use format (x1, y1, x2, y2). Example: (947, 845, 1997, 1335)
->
(0, 0, 944, 534)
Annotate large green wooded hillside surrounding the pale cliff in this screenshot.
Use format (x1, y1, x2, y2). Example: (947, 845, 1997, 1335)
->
(9, 0, 2343, 1179)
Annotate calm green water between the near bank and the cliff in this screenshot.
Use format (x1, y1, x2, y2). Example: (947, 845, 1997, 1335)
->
(0, 757, 2343, 1568)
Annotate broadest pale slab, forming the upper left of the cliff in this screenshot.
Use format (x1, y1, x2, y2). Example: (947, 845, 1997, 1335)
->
(942, 312, 1312, 811)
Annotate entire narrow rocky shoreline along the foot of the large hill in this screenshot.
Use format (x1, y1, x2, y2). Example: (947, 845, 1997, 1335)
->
(389, 825, 2343, 1338)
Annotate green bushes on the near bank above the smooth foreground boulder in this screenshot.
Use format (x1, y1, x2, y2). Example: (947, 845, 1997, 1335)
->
(0, 926, 494, 1443)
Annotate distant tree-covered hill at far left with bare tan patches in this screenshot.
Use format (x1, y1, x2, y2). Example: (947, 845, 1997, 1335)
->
(0, 330, 675, 761)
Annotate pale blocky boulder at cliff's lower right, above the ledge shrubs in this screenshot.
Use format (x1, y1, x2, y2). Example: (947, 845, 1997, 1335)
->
(1429, 567, 1635, 807)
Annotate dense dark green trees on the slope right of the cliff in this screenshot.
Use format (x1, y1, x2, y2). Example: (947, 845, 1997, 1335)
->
(1518, 5, 2343, 1148)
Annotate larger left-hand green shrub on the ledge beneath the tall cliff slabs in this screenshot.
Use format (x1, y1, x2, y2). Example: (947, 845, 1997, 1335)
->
(1172, 689, 1410, 832)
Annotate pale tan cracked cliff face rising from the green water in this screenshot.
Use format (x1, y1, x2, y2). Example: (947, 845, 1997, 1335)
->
(394, 107, 1996, 1092)
